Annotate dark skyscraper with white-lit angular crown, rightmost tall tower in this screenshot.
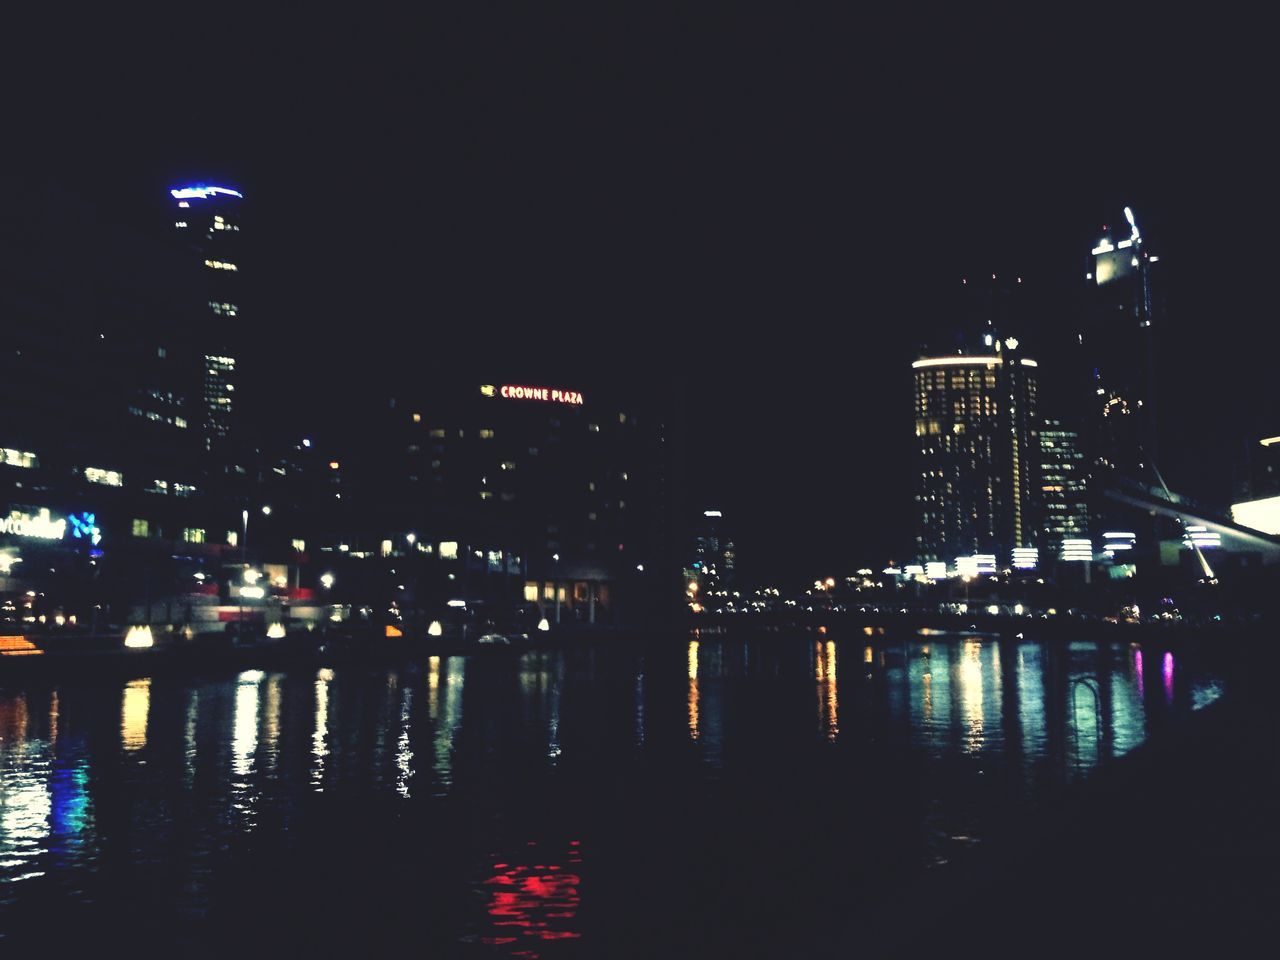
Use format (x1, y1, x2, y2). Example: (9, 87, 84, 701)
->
(1076, 207, 1162, 483)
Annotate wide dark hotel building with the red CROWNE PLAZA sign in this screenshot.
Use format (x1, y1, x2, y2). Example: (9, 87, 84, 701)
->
(326, 378, 680, 622)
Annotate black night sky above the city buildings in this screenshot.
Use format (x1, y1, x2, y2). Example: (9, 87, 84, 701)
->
(6, 5, 1280, 575)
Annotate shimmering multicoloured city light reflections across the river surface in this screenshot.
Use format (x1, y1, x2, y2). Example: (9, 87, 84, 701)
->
(0, 634, 1222, 956)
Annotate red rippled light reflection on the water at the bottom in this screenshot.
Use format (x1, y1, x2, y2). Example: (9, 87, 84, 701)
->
(483, 840, 582, 957)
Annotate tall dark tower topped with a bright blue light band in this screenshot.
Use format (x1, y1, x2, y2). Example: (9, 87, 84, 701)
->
(169, 183, 244, 451)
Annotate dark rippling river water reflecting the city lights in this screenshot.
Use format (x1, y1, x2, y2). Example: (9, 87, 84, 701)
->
(0, 632, 1221, 957)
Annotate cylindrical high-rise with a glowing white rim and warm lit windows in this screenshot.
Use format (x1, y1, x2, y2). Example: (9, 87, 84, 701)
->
(911, 337, 1042, 563)
